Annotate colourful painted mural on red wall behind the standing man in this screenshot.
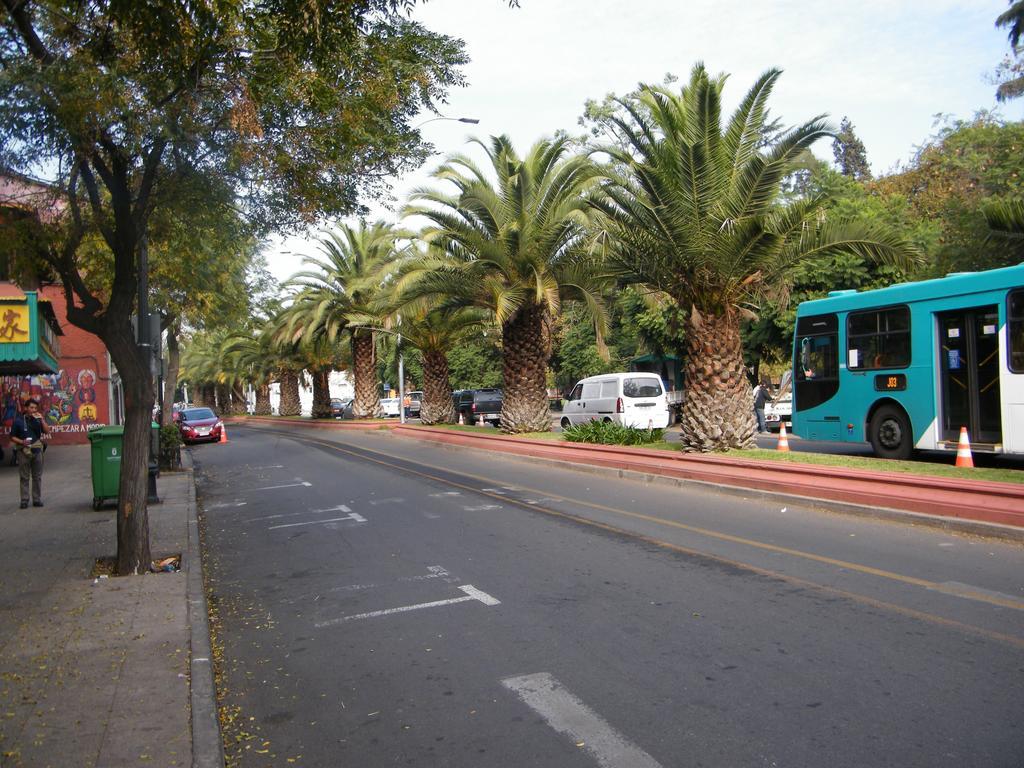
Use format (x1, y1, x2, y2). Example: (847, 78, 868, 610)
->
(0, 368, 103, 434)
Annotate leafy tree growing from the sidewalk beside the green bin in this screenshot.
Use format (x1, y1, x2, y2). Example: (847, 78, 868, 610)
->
(0, 0, 466, 573)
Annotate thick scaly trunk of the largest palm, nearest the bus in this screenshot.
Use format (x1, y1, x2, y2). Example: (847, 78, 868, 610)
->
(681, 307, 758, 453)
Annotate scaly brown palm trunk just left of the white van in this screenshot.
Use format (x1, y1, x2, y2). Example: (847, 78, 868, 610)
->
(501, 304, 551, 434)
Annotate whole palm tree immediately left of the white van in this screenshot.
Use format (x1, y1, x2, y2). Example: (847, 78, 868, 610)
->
(399, 136, 605, 432)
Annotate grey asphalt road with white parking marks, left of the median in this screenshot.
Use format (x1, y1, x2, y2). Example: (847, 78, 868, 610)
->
(194, 428, 1024, 768)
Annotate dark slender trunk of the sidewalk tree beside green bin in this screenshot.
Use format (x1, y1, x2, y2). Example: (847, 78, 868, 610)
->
(100, 318, 156, 575)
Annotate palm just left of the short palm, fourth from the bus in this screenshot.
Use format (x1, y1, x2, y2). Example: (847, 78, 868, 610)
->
(288, 221, 403, 419)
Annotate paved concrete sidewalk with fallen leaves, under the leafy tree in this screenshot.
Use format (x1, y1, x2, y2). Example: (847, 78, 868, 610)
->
(0, 445, 223, 768)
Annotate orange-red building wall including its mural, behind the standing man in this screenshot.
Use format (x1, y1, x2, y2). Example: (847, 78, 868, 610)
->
(0, 287, 111, 444)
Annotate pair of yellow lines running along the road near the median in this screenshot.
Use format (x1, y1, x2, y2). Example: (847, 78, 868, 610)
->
(235, 432, 1024, 648)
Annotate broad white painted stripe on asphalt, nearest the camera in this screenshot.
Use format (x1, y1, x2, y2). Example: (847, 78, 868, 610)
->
(502, 672, 660, 768)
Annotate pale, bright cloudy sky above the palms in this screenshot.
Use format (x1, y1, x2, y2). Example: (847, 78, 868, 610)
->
(265, 0, 1024, 281)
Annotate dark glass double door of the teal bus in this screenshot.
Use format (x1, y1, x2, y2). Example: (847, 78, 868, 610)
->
(938, 305, 1002, 443)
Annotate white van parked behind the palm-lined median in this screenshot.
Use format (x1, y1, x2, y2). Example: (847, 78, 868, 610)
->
(560, 372, 669, 429)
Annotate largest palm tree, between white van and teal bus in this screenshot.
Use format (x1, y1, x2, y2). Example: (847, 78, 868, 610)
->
(595, 65, 916, 451)
